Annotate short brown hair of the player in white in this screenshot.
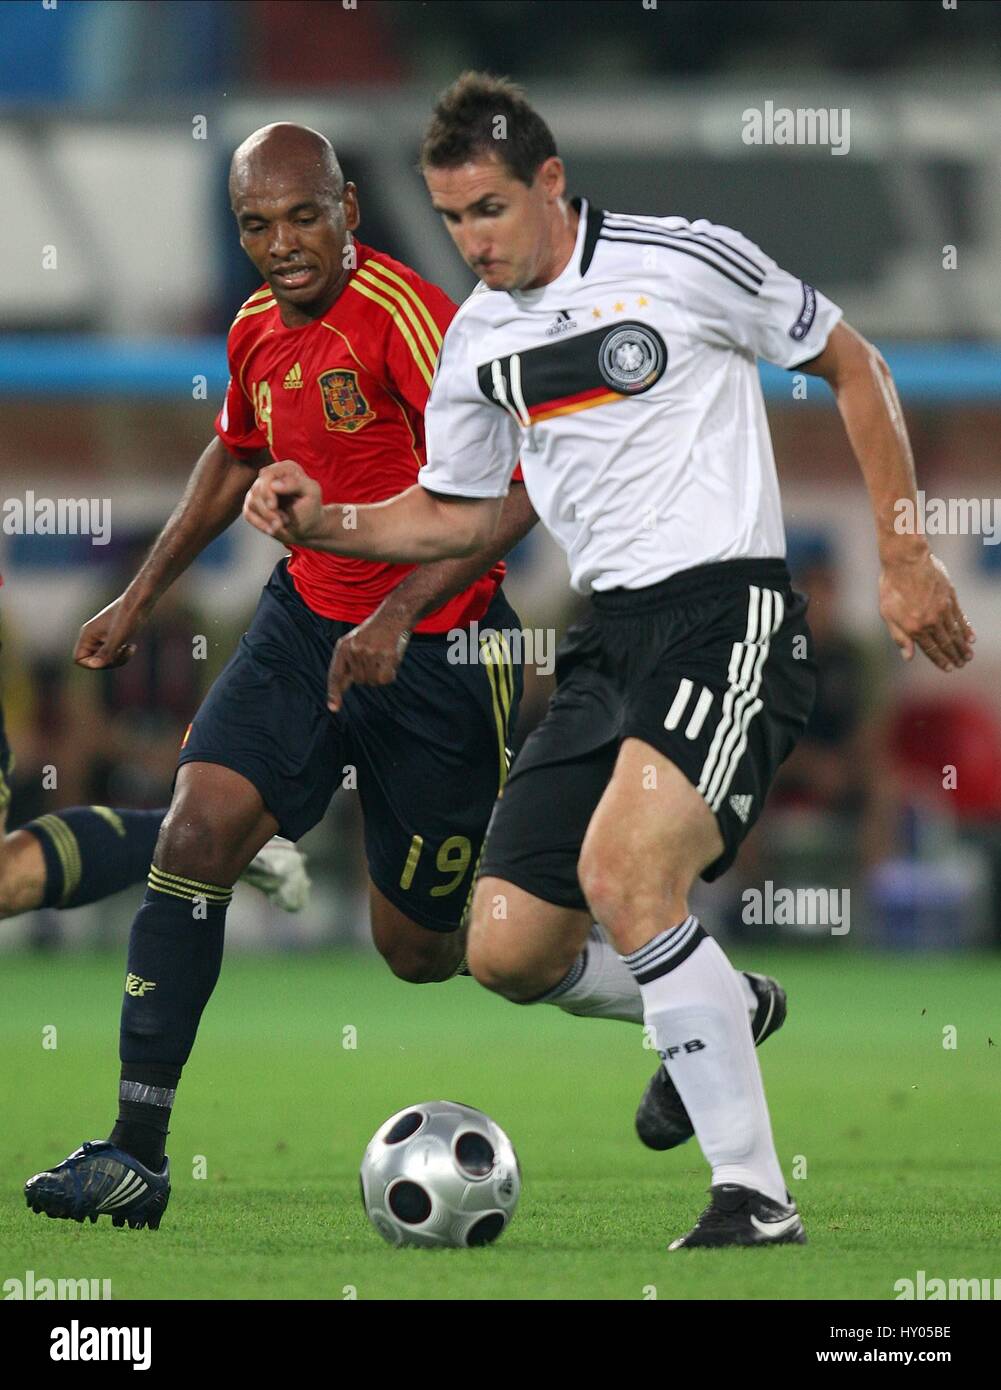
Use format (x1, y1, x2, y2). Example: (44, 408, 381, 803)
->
(418, 72, 556, 186)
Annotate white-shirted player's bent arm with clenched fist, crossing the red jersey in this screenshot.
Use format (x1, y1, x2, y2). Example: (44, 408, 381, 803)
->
(243, 459, 503, 564)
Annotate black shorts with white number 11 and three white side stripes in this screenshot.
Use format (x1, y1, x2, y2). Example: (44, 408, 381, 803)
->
(480, 560, 816, 909)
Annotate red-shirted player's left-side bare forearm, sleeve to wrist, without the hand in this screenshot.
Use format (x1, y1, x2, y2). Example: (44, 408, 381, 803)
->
(125, 439, 268, 610)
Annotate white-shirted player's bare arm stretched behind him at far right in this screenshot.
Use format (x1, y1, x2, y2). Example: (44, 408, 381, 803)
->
(802, 324, 976, 671)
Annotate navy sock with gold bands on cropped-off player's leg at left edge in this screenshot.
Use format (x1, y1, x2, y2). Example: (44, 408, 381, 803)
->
(21, 806, 167, 908)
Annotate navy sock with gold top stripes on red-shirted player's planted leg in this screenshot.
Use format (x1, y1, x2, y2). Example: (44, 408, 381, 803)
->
(110, 865, 232, 1170)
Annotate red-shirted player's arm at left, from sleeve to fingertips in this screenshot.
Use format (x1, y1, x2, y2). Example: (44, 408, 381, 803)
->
(74, 439, 268, 670)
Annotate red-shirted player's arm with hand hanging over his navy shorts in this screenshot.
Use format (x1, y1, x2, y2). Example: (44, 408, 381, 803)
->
(327, 482, 538, 713)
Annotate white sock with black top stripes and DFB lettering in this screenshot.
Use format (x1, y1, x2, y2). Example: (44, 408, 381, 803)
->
(623, 916, 787, 1204)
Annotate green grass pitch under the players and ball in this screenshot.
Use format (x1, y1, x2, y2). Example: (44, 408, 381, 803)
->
(0, 945, 1001, 1300)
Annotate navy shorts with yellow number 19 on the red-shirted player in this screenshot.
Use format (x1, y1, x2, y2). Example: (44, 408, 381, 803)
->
(179, 560, 521, 931)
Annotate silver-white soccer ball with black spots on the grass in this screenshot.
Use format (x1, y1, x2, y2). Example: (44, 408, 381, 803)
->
(361, 1101, 521, 1248)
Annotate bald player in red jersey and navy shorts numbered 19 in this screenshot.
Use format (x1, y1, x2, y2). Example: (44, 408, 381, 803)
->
(26, 124, 535, 1226)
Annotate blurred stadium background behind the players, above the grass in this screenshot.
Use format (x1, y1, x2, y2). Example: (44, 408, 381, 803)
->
(0, 0, 1001, 949)
